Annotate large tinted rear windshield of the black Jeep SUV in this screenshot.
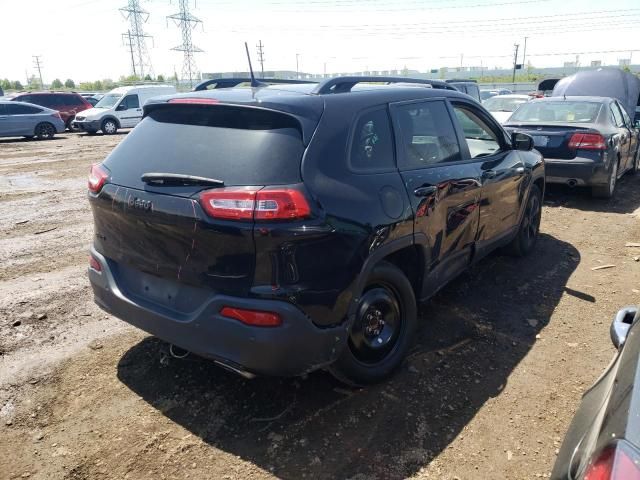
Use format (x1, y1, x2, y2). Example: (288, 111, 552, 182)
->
(104, 105, 304, 190)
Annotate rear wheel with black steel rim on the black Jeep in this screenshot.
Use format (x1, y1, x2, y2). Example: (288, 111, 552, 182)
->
(329, 262, 418, 385)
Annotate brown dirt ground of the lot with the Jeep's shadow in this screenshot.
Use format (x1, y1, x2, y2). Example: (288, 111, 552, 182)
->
(0, 134, 640, 480)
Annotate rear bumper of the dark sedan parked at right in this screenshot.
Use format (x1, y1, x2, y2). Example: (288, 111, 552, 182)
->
(544, 157, 609, 186)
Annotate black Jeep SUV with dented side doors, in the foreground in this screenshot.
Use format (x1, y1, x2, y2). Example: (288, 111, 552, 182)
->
(89, 77, 544, 384)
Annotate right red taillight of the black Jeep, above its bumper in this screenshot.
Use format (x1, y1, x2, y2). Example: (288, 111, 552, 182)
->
(200, 187, 311, 220)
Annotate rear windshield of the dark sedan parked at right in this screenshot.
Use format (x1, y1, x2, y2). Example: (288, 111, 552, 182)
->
(509, 101, 601, 123)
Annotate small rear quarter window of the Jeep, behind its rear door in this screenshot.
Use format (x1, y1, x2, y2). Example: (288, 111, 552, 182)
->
(350, 107, 395, 172)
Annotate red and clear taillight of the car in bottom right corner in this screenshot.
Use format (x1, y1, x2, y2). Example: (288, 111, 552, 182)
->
(583, 441, 640, 480)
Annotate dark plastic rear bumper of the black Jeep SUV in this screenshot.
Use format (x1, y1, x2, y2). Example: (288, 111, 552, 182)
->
(88, 248, 346, 377)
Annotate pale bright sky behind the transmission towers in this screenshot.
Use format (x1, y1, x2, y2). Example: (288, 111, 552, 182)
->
(0, 0, 640, 84)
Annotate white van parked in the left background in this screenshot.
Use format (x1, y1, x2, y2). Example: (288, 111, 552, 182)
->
(71, 85, 176, 135)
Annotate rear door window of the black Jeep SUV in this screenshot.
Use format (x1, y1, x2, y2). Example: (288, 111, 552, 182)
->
(395, 100, 462, 170)
